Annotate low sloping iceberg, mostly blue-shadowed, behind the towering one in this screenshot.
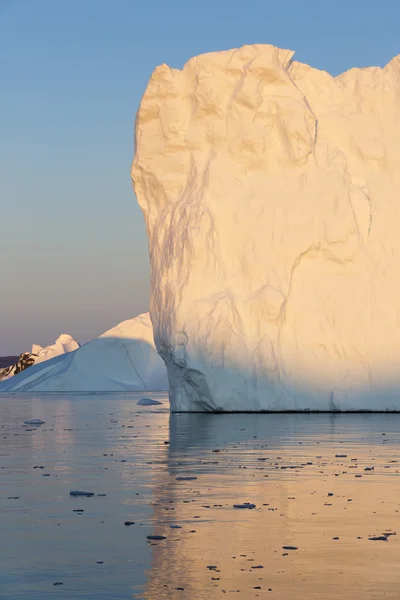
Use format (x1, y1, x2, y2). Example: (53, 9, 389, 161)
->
(0, 313, 168, 393)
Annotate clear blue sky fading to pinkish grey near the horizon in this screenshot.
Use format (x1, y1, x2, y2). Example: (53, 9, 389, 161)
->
(0, 0, 400, 355)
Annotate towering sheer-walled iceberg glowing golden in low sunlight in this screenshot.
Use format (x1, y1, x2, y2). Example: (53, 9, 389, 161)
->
(132, 45, 400, 411)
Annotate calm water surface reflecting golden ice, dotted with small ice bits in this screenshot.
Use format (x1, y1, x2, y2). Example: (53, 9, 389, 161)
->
(0, 394, 400, 600)
